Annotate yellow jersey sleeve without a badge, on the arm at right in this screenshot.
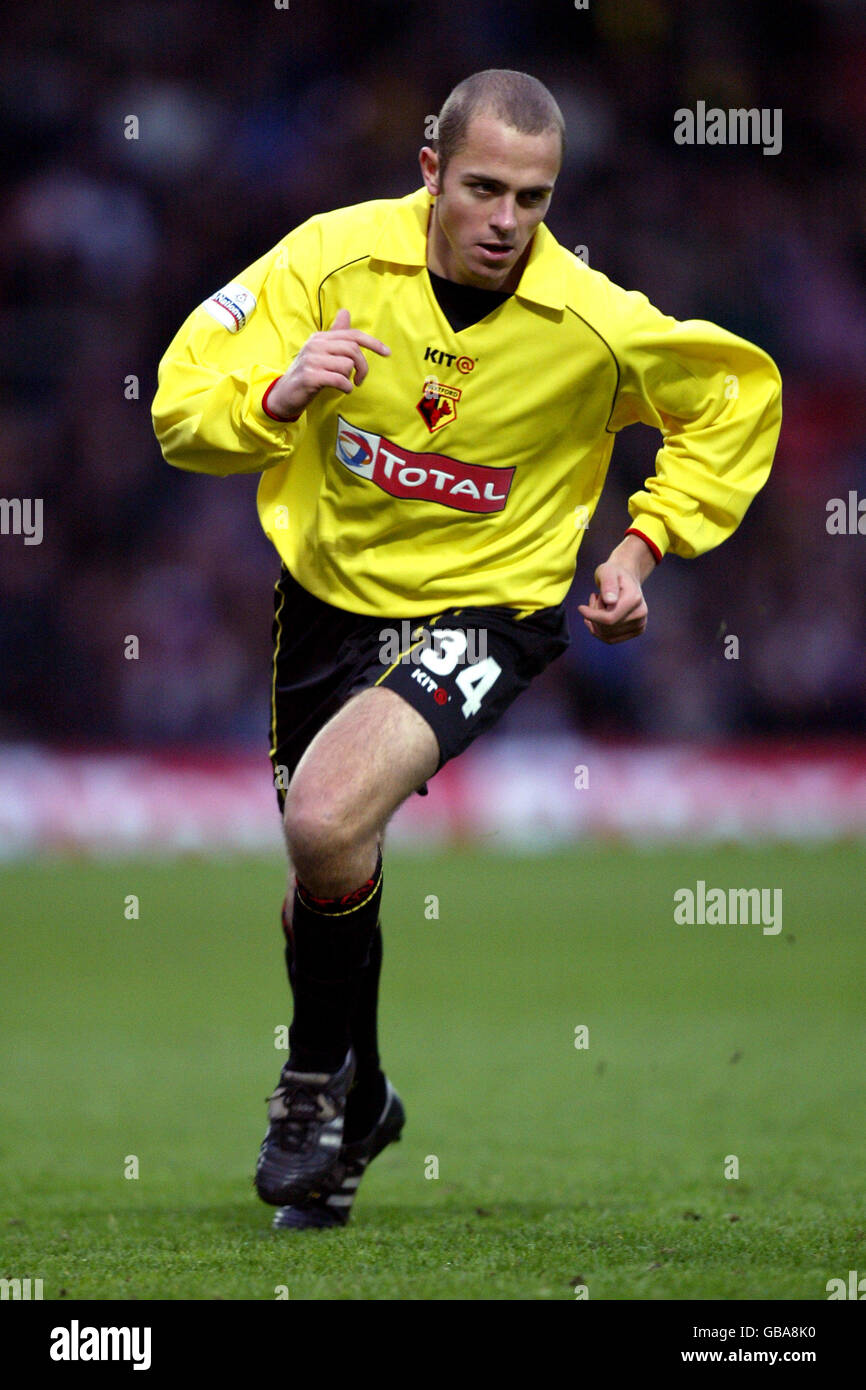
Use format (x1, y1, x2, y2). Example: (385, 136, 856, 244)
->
(610, 292, 781, 559)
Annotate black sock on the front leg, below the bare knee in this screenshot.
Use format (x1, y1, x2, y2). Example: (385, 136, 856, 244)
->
(286, 853, 382, 1072)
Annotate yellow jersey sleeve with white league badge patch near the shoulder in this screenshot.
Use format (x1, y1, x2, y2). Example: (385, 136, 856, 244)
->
(152, 224, 321, 475)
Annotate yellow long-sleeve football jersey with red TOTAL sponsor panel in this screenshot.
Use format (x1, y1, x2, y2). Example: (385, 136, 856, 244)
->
(153, 189, 781, 617)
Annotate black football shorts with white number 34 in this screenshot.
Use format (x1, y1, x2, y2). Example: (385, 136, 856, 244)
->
(271, 566, 569, 810)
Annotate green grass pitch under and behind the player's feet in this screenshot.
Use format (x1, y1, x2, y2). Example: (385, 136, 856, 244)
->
(0, 845, 866, 1300)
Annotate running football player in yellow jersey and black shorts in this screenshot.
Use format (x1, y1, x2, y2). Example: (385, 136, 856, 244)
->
(153, 70, 781, 1229)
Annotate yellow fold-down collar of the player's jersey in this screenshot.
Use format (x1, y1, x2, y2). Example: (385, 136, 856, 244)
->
(371, 188, 566, 310)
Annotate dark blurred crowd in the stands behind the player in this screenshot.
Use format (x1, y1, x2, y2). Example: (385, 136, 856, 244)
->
(0, 0, 866, 746)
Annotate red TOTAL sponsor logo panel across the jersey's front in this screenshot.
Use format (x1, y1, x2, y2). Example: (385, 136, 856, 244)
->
(335, 416, 514, 513)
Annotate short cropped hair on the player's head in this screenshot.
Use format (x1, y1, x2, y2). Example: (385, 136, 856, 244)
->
(432, 68, 566, 177)
